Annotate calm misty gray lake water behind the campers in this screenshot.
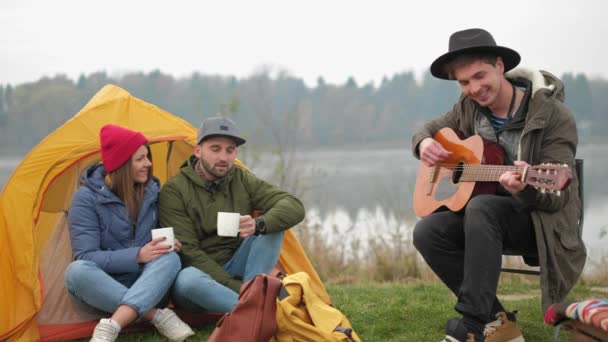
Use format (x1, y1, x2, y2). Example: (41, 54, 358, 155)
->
(0, 145, 608, 272)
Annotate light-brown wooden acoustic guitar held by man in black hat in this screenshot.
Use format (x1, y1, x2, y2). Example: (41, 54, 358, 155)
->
(414, 128, 572, 217)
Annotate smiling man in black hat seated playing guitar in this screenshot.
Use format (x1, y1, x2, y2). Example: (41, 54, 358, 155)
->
(412, 29, 586, 342)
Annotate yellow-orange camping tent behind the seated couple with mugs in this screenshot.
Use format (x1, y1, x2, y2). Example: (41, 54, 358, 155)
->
(0, 85, 329, 341)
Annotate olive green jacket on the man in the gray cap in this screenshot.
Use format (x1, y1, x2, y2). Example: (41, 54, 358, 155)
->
(158, 156, 304, 292)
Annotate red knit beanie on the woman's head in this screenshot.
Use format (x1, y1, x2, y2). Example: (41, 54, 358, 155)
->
(99, 125, 148, 172)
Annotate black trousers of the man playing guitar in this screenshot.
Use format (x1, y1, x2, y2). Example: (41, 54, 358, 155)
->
(414, 195, 537, 331)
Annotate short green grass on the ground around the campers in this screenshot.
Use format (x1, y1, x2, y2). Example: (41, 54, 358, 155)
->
(86, 277, 608, 342)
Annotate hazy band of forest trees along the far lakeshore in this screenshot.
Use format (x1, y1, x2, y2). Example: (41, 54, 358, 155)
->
(0, 68, 608, 151)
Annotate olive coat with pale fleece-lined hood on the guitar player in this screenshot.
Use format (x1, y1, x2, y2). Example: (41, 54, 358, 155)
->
(412, 69, 587, 309)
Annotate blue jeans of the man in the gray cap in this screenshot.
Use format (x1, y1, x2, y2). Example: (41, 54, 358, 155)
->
(171, 232, 285, 312)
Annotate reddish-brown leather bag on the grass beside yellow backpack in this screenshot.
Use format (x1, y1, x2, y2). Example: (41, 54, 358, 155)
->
(208, 274, 282, 342)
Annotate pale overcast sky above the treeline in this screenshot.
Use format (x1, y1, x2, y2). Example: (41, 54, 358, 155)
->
(0, 0, 608, 85)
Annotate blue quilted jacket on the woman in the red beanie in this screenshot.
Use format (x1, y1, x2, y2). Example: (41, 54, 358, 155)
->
(68, 163, 160, 274)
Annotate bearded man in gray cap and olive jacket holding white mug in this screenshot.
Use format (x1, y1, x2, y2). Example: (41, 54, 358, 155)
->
(158, 117, 304, 312)
